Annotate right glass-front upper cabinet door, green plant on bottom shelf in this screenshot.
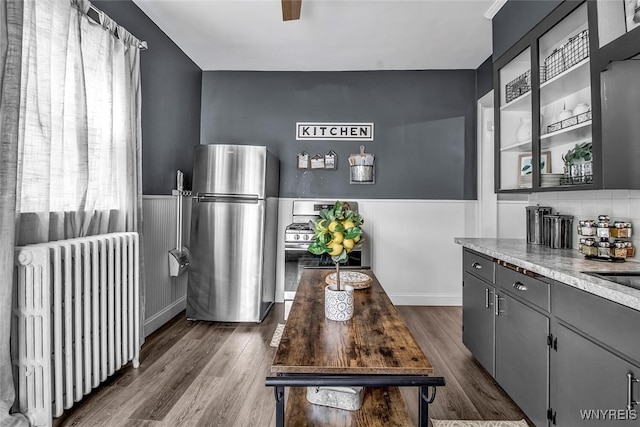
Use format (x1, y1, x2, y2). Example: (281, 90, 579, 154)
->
(538, 2, 593, 187)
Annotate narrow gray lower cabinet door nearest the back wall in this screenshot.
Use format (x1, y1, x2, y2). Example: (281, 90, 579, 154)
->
(462, 273, 495, 375)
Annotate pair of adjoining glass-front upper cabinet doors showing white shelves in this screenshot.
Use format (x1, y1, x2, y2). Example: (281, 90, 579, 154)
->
(494, 2, 594, 192)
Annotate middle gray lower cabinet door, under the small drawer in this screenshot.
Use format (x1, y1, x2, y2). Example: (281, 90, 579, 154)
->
(495, 292, 549, 426)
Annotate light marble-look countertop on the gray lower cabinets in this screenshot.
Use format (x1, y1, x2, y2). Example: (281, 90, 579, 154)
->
(455, 237, 640, 310)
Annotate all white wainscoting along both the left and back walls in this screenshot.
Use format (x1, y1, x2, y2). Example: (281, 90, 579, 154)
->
(143, 196, 496, 335)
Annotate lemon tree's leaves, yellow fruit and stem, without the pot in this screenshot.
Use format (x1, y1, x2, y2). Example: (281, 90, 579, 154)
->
(308, 200, 364, 290)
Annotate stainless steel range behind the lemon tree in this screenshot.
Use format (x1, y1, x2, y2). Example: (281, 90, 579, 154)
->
(284, 199, 371, 320)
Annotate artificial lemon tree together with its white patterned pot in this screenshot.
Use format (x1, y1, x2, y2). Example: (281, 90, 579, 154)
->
(309, 201, 364, 320)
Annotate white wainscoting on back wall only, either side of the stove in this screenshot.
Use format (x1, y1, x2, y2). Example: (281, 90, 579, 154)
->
(276, 199, 478, 305)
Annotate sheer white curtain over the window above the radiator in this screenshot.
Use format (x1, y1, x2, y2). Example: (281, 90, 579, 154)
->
(18, 0, 140, 244)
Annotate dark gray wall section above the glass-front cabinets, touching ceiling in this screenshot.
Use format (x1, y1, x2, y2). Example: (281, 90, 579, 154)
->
(492, 0, 564, 61)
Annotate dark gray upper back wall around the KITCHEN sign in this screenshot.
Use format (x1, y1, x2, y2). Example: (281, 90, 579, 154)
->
(201, 70, 476, 199)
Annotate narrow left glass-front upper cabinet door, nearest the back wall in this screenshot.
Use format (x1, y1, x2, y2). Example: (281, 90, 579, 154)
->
(498, 48, 533, 190)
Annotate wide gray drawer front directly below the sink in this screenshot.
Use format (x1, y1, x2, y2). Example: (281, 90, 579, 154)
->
(553, 283, 640, 361)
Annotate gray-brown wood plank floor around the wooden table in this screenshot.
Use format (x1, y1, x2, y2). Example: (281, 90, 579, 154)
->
(54, 304, 525, 427)
